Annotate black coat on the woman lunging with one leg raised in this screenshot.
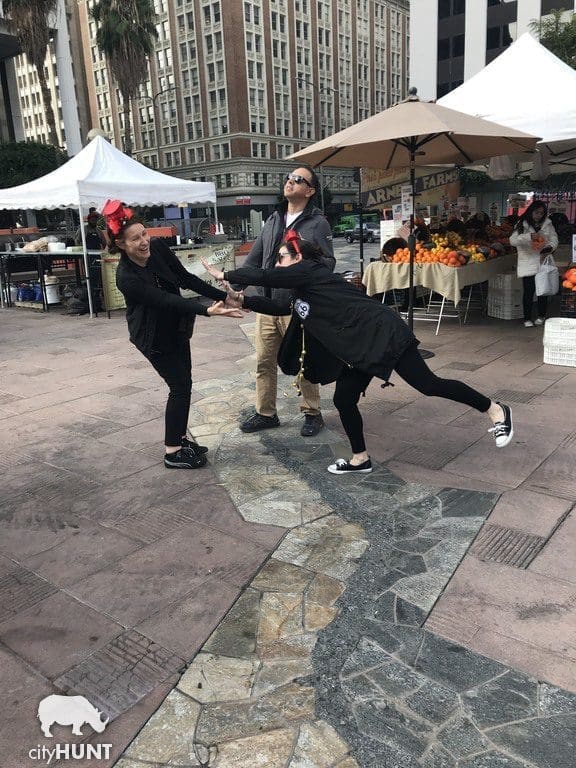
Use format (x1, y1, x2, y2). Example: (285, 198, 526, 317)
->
(225, 260, 419, 384)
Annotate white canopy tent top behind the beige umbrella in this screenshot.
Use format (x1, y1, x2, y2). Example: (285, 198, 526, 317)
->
(438, 32, 576, 171)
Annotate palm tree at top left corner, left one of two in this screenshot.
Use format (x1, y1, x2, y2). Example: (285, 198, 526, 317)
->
(4, 0, 59, 147)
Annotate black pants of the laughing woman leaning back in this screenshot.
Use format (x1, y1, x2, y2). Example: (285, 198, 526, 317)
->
(147, 339, 192, 446)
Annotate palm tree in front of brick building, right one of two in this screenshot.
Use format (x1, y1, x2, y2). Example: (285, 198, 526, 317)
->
(90, 0, 158, 155)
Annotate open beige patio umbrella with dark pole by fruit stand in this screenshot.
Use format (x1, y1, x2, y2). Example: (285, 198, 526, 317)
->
(289, 88, 539, 328)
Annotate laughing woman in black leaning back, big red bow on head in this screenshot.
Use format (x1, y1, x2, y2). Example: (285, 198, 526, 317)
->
(102, 200, 242, 469)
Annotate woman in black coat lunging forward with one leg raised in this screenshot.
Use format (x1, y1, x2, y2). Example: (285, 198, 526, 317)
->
(204, 233, 513, 474)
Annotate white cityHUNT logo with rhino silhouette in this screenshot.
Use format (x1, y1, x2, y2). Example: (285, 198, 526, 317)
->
(28, 694, 112, 765)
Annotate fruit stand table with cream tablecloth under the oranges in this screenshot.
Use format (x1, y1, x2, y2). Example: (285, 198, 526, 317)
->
(362, 253, 516, 333)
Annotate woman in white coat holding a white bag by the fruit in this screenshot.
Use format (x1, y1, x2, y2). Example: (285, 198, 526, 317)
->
(510, 200, 558, 328)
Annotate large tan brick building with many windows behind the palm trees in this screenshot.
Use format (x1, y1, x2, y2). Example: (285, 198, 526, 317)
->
(80, 0, 409, 216)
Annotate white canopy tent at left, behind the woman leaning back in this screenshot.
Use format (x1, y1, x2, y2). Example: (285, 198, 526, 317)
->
(0, 136, 218, 317)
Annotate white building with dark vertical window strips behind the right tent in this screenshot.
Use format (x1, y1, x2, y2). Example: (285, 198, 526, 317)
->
(410, 0, 576, 99)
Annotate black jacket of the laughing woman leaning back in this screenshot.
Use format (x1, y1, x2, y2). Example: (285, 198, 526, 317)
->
(116, 239, 226, 355)
